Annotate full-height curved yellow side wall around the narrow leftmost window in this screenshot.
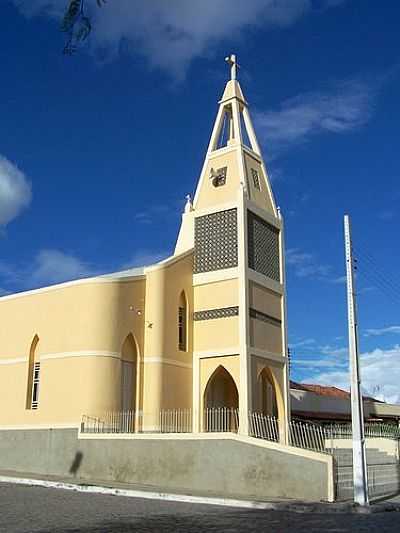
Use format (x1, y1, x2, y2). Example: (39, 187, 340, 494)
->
(0, 279, 145, 425)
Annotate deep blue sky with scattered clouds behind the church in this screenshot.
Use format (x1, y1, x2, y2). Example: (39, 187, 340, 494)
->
(0, 0, 400, 402)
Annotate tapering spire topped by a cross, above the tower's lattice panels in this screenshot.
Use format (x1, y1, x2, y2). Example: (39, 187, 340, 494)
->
(176, 54, 278, 255)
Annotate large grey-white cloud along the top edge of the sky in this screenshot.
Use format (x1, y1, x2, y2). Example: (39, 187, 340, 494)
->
(13, 0, 339, 78)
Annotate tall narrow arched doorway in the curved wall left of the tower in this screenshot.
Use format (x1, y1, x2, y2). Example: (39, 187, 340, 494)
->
(121, 333, 138, 411)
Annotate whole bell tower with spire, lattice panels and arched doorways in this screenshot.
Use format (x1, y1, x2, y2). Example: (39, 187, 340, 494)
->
(175, 55, 289, 442)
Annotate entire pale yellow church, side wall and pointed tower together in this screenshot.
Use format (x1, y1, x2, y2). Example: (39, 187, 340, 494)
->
(0, 56, 289, 443)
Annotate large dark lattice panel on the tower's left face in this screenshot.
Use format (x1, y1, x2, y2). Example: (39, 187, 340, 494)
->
(194, 209, 238, 274)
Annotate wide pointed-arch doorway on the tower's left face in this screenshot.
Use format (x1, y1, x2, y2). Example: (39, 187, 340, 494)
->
(204, 366, 239, 432)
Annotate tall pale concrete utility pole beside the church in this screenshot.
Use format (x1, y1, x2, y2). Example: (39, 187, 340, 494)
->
(344, 215, 369, 505)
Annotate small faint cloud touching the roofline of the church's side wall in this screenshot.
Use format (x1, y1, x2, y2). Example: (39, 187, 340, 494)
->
(26, 250, 95, 287)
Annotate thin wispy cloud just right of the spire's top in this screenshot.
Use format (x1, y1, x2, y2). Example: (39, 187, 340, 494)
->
(255, 80, 376, 158)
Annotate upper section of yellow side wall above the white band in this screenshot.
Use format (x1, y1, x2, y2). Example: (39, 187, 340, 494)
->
(0, 280, 145, 360)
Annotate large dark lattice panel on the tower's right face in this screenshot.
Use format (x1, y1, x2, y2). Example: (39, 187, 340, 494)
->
(248, 211, 280, 282)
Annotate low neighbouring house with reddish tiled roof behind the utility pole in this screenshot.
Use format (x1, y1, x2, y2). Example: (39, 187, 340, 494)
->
(290, 381, 400, 425)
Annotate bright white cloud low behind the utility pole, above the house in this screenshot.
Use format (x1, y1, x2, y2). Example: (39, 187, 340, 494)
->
(306, 344, 400, 403)
